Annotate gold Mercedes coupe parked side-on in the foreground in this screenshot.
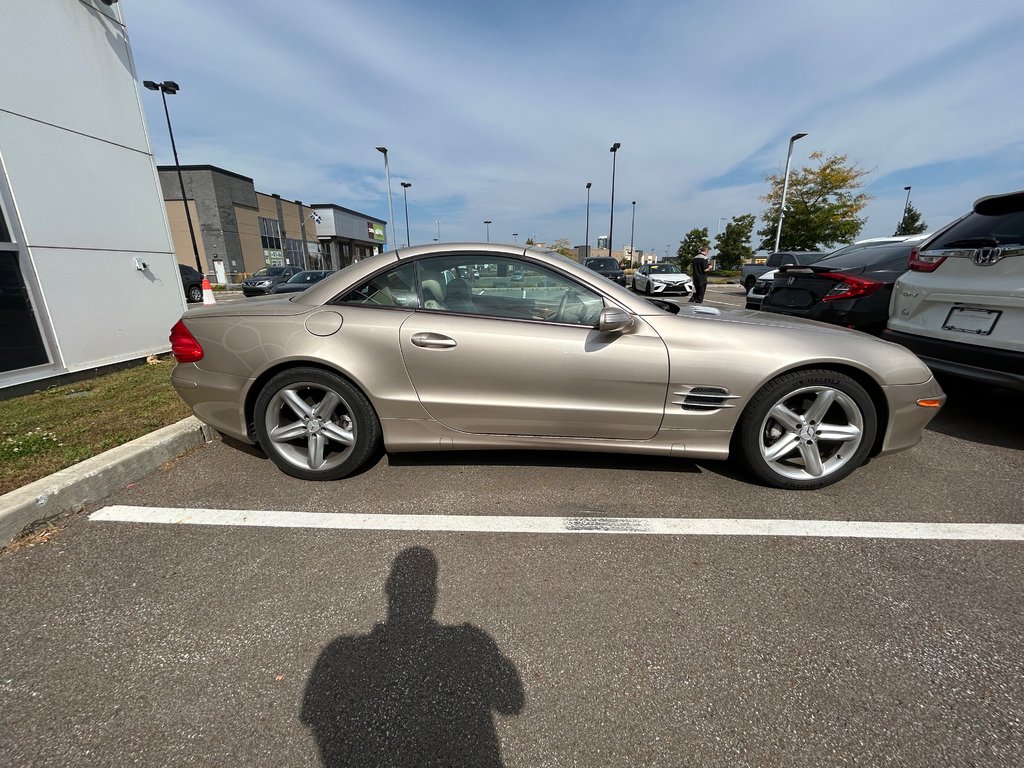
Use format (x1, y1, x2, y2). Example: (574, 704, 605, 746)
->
(171, 243, 945, 489)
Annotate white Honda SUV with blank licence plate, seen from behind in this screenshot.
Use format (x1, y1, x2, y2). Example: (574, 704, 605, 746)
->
(882, 191, 1024, 391)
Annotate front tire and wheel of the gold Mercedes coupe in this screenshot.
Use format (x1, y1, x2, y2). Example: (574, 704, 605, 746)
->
(734, 370, 878, 490)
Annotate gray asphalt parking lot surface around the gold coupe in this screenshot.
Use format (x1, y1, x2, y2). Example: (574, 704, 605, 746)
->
(0, 286, 1024, 766)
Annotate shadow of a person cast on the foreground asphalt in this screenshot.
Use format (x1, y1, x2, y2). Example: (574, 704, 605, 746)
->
(301, 547, 523, 768)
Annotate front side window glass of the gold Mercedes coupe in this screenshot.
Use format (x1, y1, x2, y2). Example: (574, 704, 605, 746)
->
(416, 254, 604, 326)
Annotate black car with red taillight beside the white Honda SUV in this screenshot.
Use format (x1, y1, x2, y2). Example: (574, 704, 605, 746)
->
(761, 242, 914, 334)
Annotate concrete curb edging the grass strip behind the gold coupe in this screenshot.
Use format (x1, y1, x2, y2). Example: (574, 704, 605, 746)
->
(0, 416, 216, 548)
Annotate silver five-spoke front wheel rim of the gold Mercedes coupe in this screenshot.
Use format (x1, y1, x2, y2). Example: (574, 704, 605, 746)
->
(758, 385, 864, 480)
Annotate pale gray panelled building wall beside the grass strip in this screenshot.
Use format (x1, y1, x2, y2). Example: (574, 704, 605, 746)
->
(0, 0, 185, 387)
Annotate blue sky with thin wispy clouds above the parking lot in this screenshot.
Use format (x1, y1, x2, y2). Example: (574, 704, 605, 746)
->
(121, 0, 1024, 259)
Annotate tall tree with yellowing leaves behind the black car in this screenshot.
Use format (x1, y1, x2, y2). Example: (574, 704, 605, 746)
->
(758, 152, 871, 251)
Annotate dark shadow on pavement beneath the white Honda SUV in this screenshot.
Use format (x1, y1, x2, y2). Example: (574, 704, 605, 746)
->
(928, 377, 1024, 450)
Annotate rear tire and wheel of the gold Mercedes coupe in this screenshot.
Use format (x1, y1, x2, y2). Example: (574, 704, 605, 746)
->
(253, 368, 382, 480)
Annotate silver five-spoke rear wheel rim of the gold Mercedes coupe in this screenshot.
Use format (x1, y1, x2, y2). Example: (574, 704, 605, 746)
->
(264, 381, 358, 471)
